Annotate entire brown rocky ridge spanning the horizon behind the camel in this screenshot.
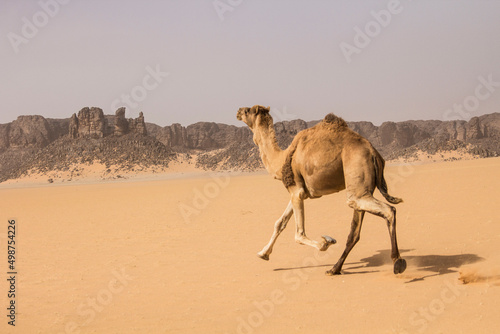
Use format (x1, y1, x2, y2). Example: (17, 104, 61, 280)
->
(0, 107, 500, 181)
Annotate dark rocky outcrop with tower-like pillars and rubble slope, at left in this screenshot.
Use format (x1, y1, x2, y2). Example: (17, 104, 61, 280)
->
(0, 107, 155, 182)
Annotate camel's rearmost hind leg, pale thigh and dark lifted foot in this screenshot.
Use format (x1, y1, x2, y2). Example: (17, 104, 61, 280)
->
(340, 195, 406, 274)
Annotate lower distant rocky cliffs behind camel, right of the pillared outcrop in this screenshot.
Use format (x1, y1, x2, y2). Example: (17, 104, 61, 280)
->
(178, 113, 500, 169)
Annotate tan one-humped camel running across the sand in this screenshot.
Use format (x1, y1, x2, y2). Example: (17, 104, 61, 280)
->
(236, 105, 406, 275)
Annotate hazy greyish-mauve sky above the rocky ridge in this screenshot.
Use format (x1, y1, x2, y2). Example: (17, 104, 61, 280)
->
(0, 0, 500, 125)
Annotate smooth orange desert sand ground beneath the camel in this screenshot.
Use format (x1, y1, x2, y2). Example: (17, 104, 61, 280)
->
(0, 158, 500, 333)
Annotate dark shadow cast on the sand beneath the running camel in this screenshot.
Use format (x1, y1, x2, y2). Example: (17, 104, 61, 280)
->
(274, 249, 484, 283)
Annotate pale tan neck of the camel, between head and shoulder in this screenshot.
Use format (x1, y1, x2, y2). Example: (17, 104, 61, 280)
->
(253, 124, 286, 180)
